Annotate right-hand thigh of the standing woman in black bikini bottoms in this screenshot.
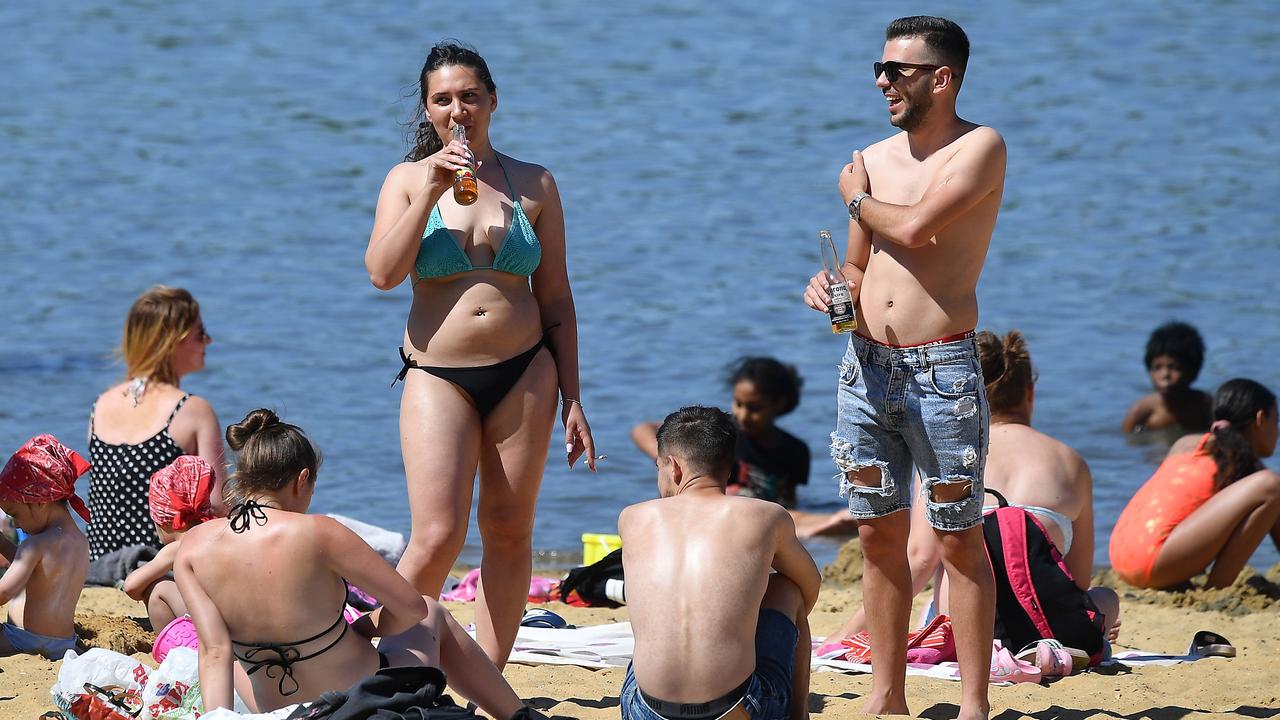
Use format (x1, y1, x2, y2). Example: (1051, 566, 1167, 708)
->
(477, 350, 558, 532)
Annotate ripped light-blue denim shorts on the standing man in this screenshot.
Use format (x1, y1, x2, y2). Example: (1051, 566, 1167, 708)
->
(831, 334, 989, 532)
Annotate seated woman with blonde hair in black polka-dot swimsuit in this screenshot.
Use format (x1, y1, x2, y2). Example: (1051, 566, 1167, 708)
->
(87, 286, 224, 560)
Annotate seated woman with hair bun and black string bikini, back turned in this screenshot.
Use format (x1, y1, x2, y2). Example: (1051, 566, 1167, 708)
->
(174, 410, 532, 717)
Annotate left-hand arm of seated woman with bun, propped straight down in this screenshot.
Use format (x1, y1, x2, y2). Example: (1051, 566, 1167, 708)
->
(173, 528, 234, 711)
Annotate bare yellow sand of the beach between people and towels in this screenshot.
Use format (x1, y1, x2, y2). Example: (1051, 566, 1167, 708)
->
(0, 546, 1280, 720)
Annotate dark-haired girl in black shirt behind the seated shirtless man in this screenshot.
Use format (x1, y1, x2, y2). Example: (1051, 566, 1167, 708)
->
(631, 357, 809, 507)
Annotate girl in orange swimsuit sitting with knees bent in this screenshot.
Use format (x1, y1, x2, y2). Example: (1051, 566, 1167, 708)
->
(1111, 378, 1280, 588)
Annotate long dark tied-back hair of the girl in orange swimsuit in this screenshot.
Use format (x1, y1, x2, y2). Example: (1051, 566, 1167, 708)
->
(1208, 378, 1276, 491)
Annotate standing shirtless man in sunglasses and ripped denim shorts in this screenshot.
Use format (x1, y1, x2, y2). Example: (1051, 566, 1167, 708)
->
(805, 17, 1005, 717)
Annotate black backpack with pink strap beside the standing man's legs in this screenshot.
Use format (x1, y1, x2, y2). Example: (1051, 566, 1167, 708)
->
(982, 489, 1103, 665)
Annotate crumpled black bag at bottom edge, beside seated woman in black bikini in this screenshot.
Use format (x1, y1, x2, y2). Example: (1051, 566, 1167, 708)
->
(288, 665, 480, 720)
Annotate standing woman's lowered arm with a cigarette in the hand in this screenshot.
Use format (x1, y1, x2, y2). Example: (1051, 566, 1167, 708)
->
(532, 170, 595, 470)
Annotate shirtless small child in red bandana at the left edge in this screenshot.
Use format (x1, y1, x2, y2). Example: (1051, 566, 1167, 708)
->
(0, 434, 88, 660)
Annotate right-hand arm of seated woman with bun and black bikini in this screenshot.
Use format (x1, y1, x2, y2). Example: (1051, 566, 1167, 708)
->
(310, 515, 426, 638)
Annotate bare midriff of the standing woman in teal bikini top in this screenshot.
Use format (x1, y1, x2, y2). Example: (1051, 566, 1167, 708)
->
(404, 270, 543, 368)
